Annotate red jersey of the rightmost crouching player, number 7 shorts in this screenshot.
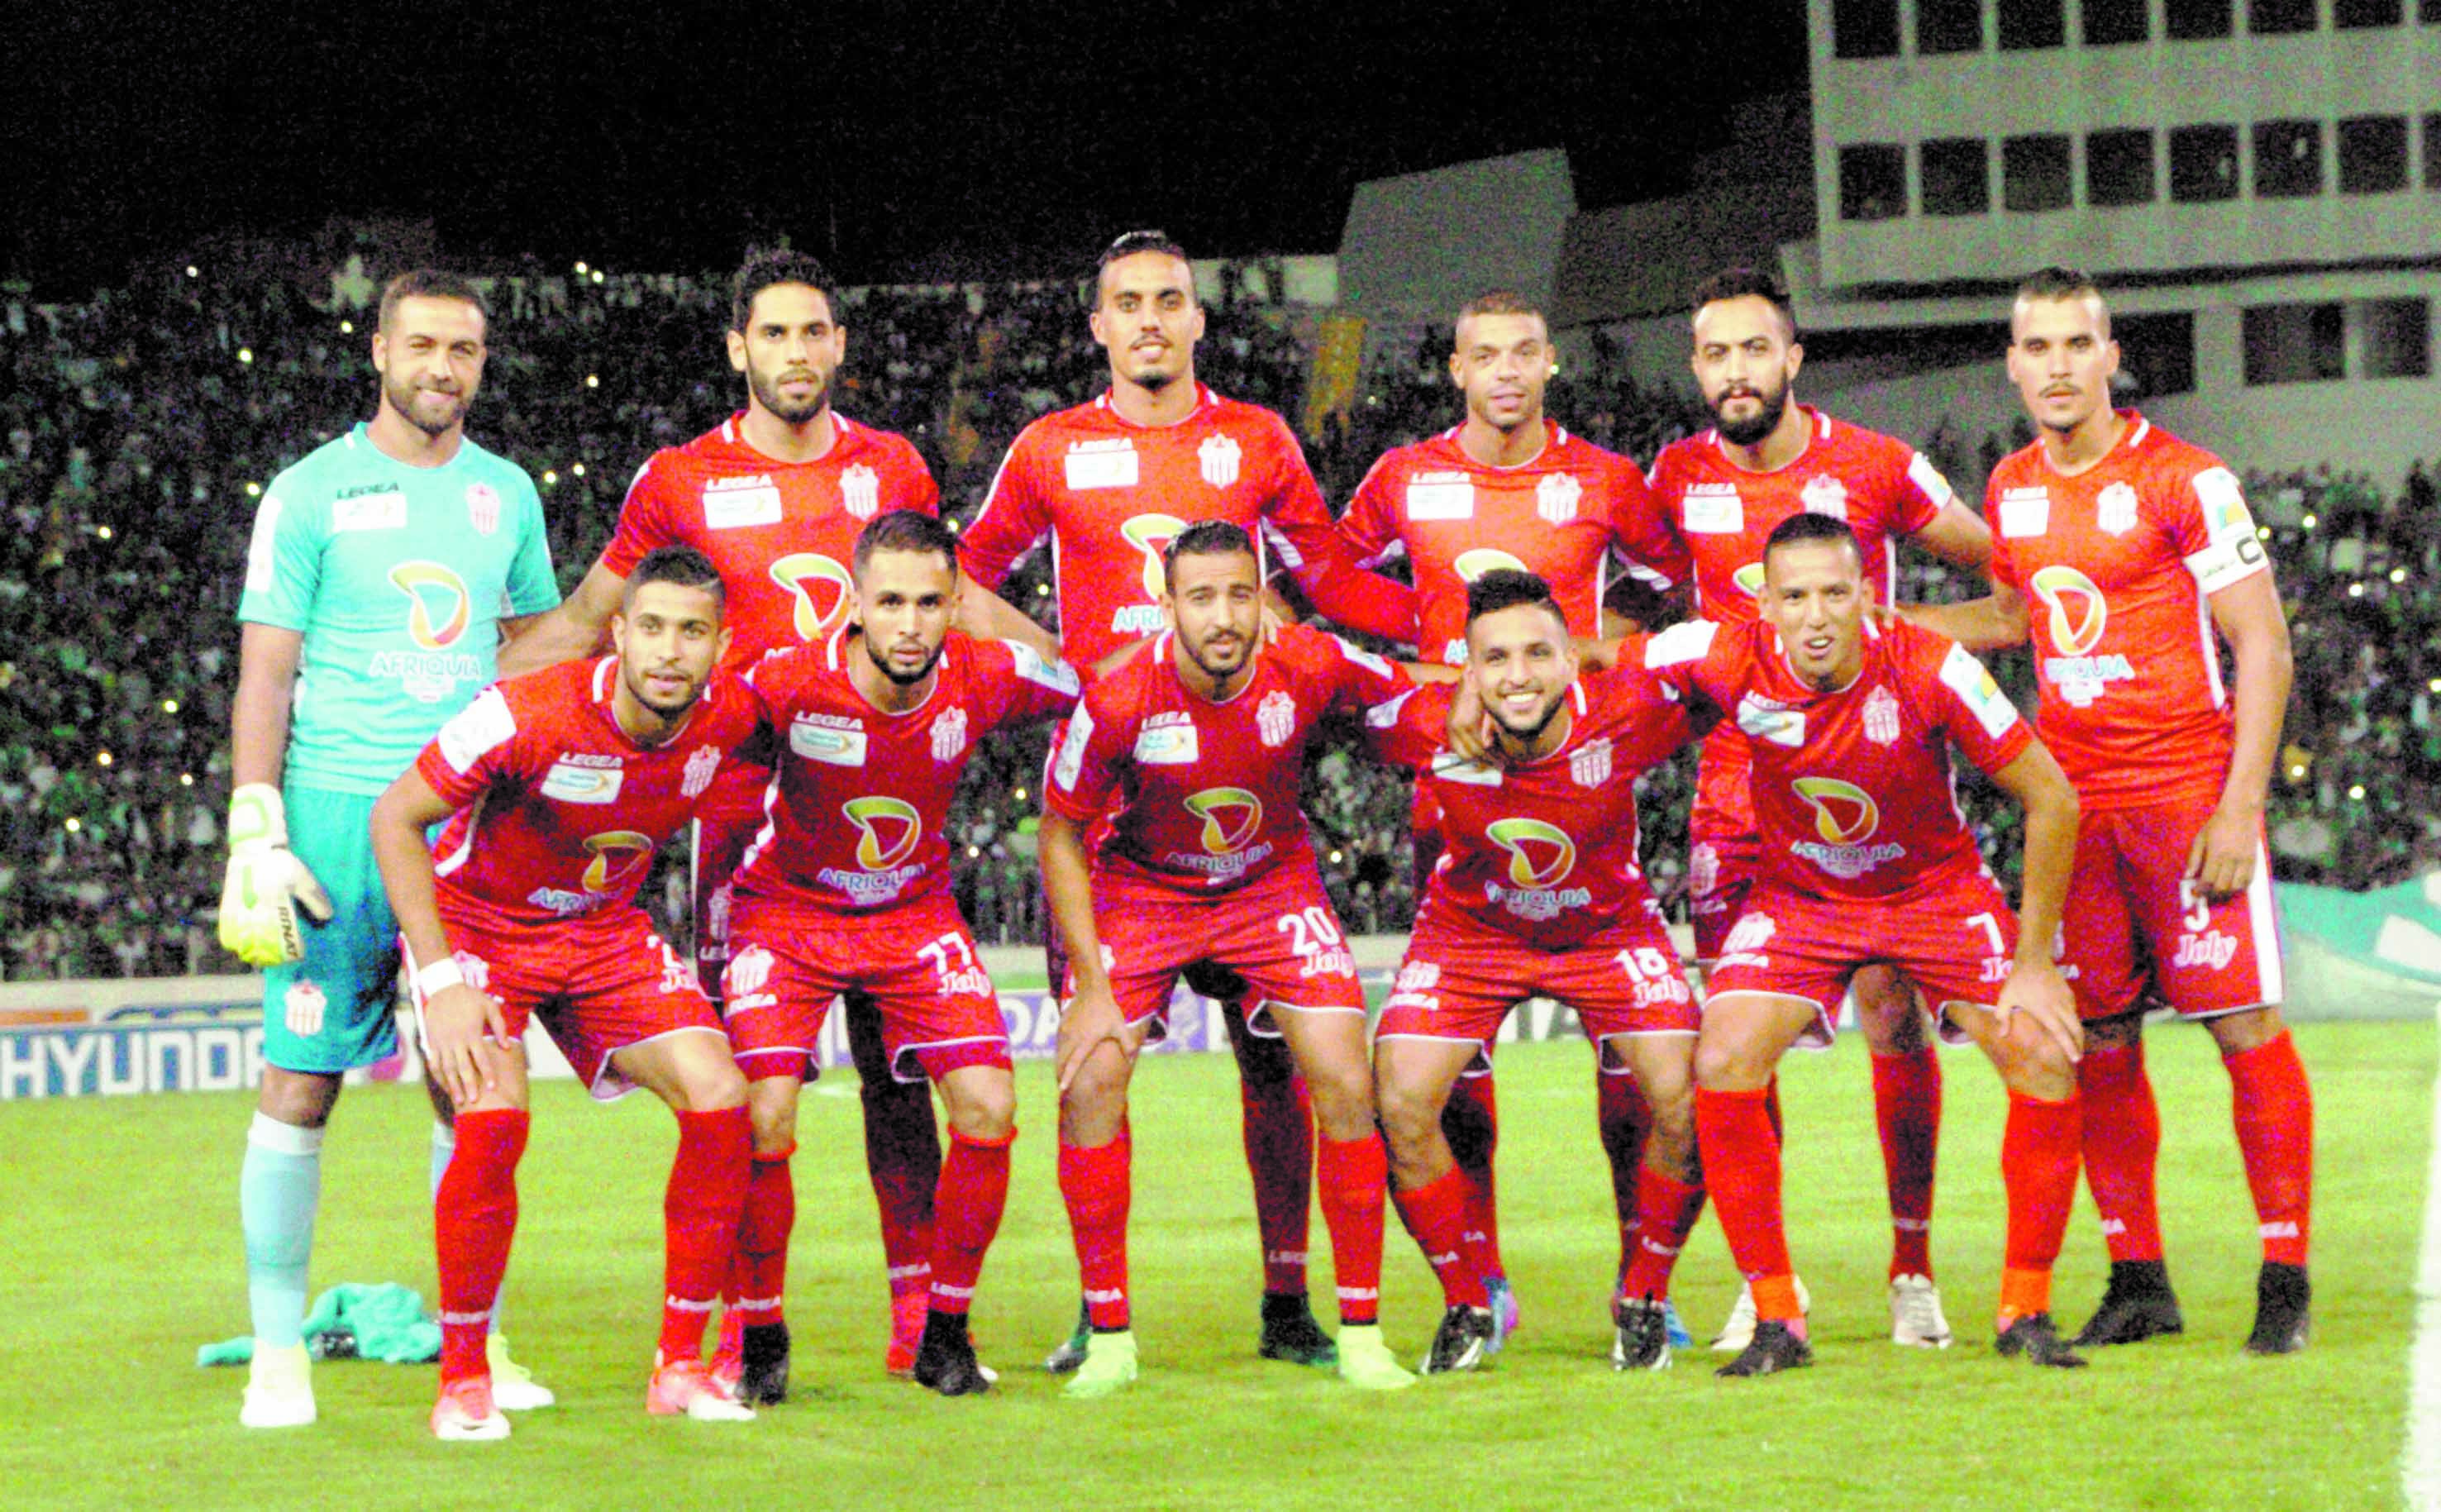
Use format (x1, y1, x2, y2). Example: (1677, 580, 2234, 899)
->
(1642, 621, 2033, 901)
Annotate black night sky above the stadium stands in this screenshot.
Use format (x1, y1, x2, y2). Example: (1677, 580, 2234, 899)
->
(0, 0, 1806, 293)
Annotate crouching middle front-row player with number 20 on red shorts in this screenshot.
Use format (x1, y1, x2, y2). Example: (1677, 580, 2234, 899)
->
(1042, 520, 1416, 1397)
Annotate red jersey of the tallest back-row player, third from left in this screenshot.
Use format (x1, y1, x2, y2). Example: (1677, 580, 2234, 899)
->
(960, 389, 1416, 667)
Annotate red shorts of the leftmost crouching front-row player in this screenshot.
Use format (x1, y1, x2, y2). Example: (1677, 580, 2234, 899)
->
(415, 906, 720, 1102)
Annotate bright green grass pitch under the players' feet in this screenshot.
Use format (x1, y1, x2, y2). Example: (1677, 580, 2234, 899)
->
(0, 1023, 2434, 1512)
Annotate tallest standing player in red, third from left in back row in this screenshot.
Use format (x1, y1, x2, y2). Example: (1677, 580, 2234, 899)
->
(960, 232, 1416, 1371)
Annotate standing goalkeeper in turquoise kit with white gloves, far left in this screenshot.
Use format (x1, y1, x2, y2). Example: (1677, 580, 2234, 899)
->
(220, 271, 559, 1429)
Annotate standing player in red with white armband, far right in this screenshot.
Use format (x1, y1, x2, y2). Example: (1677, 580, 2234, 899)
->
(1921, 269, 2314, 1353)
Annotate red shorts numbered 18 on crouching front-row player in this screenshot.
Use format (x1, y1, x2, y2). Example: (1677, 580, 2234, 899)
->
(1375, 901, 1699, 1072)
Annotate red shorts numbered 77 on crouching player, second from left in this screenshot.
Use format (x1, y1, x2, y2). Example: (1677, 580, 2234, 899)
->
(722, 894, 1011, 1082)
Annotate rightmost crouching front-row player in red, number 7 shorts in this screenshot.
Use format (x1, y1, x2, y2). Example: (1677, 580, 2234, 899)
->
(1645, 513, 2085, 1376)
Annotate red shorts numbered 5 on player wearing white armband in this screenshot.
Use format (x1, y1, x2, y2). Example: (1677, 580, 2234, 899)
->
(2060, 799, 2285, 1018)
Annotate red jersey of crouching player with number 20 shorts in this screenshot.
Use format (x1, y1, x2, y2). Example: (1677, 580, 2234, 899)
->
(1045, 625, 1414, 891)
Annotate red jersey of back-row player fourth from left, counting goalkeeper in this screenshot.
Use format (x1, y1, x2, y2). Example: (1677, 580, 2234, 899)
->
(1340, 420, 1687, 667)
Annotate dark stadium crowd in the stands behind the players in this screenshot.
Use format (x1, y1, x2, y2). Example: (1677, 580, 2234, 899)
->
(0, 269, 2441, 980)
